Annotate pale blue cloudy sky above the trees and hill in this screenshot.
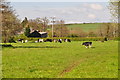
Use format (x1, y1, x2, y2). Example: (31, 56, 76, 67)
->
(11, 0, 111, 23)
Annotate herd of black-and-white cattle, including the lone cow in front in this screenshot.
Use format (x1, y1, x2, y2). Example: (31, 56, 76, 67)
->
(18, 39, 92, 48)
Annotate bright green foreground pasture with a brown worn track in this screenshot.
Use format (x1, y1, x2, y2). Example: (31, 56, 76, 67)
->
(2, 41, 118, 78)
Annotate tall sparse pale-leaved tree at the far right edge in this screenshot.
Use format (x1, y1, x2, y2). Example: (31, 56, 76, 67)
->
(109, 0, 120, 37)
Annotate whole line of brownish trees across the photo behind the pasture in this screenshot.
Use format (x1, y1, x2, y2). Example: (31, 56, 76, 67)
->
(0, 0, 120, 43)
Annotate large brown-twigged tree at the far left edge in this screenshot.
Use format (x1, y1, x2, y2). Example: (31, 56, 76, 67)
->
(0, 0, 22, 43)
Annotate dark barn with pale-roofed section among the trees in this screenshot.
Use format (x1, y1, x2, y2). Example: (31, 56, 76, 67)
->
(28, 30, 47, 38)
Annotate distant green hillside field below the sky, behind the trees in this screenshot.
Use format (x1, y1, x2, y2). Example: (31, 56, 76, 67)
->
(66, 23, 102, 31)
